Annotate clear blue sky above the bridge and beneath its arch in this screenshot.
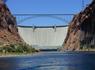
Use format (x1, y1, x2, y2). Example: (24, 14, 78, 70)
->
(6, 0, 91, 26)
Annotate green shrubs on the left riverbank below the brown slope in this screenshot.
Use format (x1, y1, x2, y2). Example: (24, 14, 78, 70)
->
(0, 44, 36, 54)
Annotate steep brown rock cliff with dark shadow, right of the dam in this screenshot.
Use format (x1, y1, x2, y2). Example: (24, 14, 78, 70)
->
(62, 0, 95, 51)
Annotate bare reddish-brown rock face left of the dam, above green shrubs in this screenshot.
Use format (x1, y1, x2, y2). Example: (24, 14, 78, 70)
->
(0, 0, 23, 44)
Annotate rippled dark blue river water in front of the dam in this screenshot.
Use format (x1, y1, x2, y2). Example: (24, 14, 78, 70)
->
(0, 52, 95, 70)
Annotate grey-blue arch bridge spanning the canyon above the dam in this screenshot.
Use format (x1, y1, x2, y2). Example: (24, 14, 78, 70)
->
(17, 14, 74, 24)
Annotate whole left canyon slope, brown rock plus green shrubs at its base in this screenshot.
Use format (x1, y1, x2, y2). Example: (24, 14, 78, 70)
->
(0, 0, 37, 56)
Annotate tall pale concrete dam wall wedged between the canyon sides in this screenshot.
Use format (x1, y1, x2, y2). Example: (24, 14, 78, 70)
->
(18, 26, 68, 49)
